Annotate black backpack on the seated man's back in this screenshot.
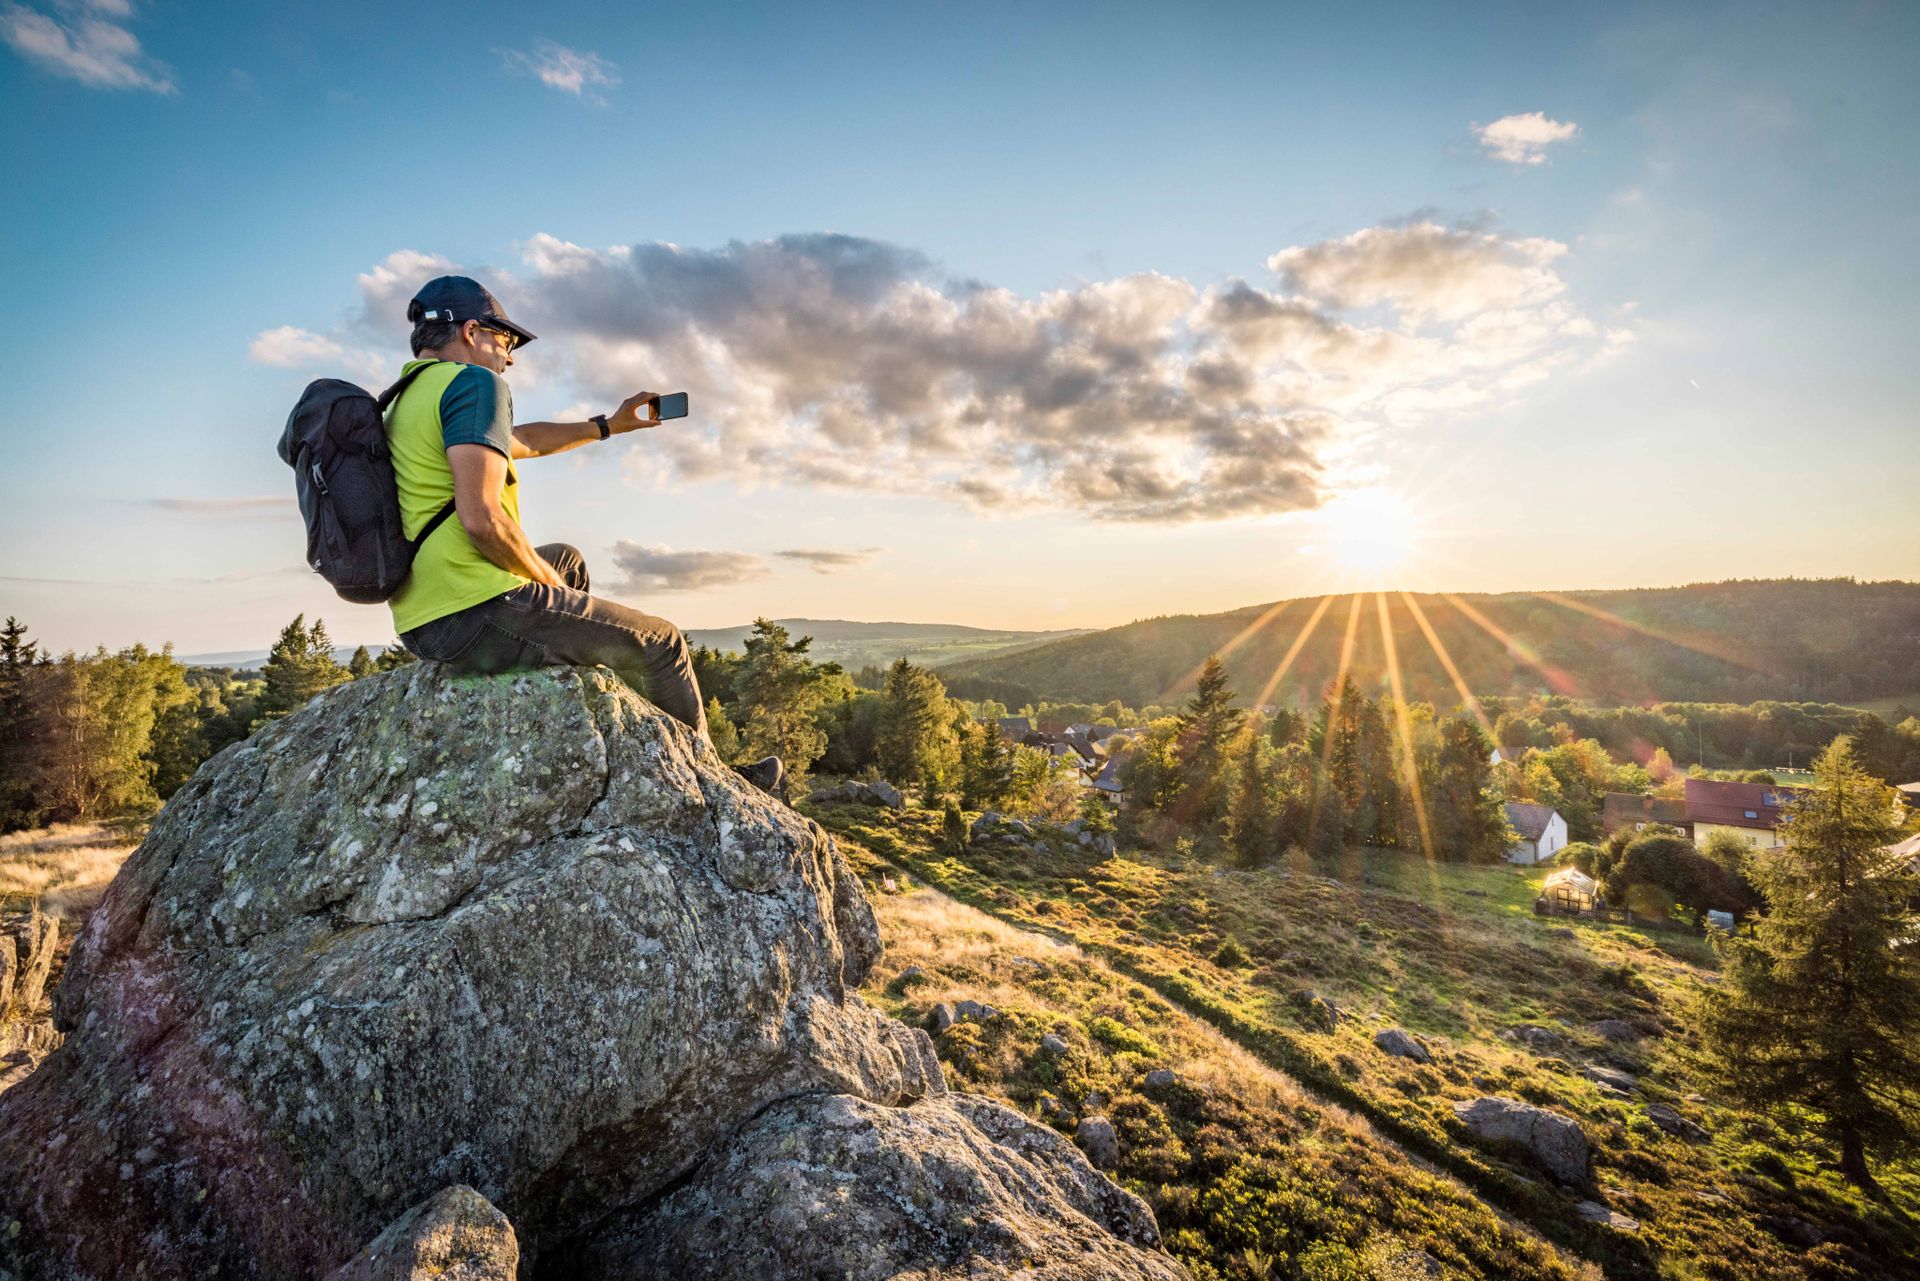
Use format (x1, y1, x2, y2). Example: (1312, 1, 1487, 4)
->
(280, 365, 453, 605)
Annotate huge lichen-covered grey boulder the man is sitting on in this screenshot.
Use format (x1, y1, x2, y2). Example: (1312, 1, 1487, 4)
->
(0, 665, 1182, 1279)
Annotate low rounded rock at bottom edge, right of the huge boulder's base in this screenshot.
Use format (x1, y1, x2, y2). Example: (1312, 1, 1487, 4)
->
(568, 1095, 1187, 1281)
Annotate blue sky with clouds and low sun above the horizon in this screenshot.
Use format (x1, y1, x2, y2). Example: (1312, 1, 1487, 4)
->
(0, 0, 1920, 653)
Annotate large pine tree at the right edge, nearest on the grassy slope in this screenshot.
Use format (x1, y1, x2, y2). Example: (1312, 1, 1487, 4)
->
(1701, 737, 1920, 1189)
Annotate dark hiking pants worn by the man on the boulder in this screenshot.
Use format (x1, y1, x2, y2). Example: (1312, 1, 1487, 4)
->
(399, 544, 707, 739)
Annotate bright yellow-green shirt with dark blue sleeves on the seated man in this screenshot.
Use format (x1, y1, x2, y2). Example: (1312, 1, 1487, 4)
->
(386, 361, 528, 632)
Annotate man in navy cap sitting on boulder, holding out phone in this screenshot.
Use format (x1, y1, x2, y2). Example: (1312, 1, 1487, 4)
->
(386, 277, 783, 791)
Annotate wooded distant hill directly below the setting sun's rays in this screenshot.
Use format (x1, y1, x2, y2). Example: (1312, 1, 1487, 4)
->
(943, 578, 1920, 707)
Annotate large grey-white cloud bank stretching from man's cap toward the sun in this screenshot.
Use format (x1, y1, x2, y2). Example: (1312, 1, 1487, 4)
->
(270, 219, 1626, 526)
